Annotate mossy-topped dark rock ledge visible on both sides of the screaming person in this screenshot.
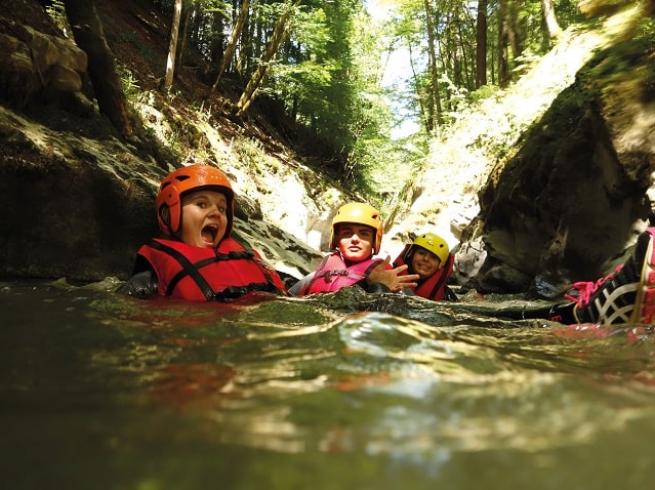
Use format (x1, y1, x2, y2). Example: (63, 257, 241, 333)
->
(0, 101, 320, 281)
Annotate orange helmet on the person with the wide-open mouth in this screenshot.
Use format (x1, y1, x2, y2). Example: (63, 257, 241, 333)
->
(155, 164, 234, 237)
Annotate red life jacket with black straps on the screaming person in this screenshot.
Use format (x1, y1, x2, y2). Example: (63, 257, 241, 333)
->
(137, 238, 285, 301)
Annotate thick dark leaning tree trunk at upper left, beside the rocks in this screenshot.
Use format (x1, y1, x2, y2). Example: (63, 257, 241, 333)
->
(64, 0, 132, 138)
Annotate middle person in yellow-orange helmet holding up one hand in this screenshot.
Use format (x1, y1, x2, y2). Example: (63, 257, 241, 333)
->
(289, 203, 419, 296)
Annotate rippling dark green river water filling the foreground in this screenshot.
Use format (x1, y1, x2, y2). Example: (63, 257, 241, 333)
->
(0, 284, 655, 490)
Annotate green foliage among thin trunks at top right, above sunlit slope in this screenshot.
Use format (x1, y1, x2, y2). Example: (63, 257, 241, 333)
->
(380, 0, 596, 143)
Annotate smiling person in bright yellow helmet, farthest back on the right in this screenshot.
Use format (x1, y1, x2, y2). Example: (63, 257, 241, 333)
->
(393, 233, 457, 301)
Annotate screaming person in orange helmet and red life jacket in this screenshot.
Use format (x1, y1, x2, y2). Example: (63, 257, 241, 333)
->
(120, 164, 286, 301)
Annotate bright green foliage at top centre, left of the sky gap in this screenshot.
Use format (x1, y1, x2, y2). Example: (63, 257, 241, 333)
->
(258, 0, 400, 199)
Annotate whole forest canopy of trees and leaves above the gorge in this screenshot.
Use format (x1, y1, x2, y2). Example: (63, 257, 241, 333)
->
(45, 0, 652, 199)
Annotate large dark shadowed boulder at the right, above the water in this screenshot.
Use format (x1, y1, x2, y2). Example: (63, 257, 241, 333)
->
(477, 39, 655, 291)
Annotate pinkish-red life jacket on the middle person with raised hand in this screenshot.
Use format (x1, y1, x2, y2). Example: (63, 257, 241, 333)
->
(298, 252, 382, 296)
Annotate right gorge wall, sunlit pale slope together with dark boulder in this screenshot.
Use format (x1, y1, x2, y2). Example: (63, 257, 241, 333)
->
(389, 20, 655, 291)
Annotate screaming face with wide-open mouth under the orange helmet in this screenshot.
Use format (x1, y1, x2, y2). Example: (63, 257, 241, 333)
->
(182, 189, 227, 247)
